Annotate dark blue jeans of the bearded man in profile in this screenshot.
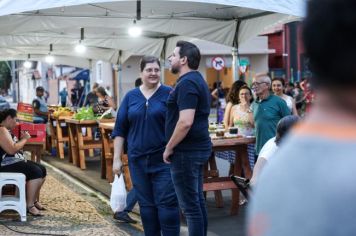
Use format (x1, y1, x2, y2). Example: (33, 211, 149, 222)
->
(171, 151, 211, 236)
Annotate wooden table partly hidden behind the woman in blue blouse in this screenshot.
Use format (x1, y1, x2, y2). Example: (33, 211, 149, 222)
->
(99, 122, 132, 190)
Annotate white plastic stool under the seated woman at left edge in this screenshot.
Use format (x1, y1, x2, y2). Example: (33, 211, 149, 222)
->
(0, 172, 26, 221)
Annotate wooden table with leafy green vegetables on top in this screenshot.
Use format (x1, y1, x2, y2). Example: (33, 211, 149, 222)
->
(65, 118, 102, 170)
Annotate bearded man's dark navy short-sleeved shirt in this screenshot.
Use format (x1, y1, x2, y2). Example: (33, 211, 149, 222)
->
(166, 71, 211, 152)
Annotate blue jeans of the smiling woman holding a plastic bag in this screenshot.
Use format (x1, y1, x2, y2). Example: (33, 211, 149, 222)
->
(129, 153, 180, 236)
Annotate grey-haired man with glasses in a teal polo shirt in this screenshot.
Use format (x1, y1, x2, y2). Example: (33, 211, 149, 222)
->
(251, 74, 291, 156)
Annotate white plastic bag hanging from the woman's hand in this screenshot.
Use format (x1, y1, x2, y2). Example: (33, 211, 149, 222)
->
(110, 174, 127, 213)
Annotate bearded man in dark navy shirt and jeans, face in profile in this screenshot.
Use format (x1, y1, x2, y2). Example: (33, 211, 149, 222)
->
(163, 41, 211, 235)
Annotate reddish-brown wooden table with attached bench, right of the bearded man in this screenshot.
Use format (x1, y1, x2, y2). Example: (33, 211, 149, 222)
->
(203, 138, 256, 215)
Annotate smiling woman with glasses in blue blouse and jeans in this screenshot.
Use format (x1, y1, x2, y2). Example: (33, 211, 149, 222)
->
(112, 56, 180, 236)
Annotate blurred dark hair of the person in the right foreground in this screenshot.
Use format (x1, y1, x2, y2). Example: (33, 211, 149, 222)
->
(303, 0, 356, 89)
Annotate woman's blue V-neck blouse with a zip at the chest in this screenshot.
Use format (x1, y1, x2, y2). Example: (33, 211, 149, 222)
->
(112, 85, 171, 158)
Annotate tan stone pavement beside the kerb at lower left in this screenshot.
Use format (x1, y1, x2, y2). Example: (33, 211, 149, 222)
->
(0, 168, 143, 236)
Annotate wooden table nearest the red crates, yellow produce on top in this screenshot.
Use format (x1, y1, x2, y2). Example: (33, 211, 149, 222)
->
(49, 115, 72, 159)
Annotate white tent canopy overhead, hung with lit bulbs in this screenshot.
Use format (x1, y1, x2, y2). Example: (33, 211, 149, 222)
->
(0, 0, 305, 64)
